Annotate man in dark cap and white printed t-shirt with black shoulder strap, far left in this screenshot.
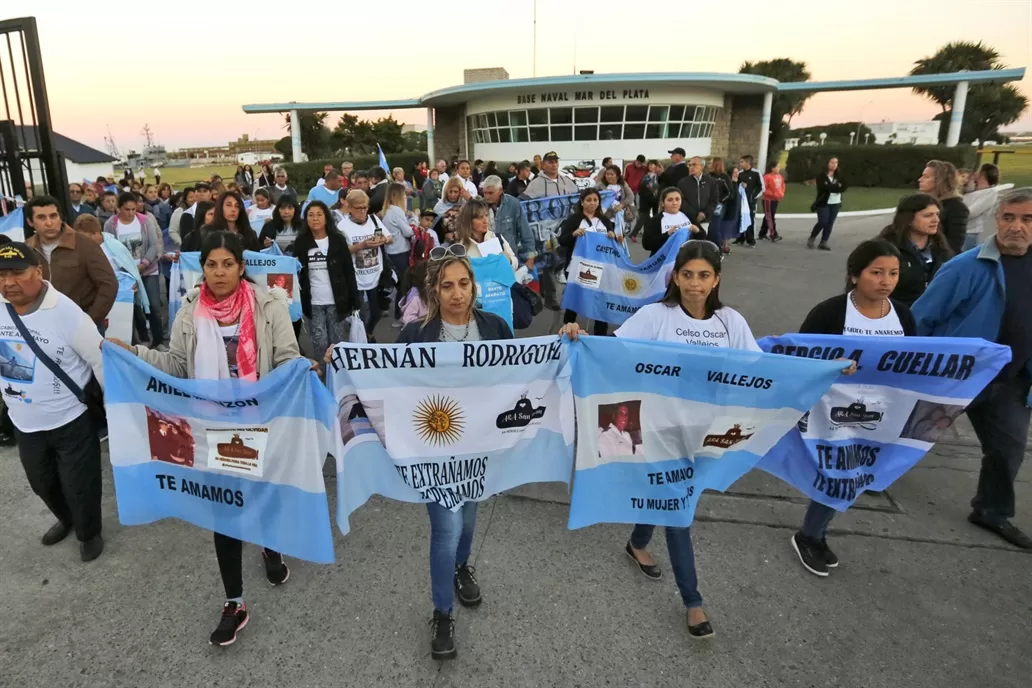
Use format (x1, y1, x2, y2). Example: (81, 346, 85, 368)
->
(0, 242, 104, 561)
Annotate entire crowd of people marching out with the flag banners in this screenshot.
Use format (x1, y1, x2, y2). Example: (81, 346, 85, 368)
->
(0, 149, 1032, 658)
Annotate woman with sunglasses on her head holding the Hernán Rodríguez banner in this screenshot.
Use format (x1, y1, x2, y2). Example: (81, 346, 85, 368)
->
(392, 247, 513, 659)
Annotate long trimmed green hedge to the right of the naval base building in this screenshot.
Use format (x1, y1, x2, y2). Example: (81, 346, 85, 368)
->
(785, 145, 977, 189)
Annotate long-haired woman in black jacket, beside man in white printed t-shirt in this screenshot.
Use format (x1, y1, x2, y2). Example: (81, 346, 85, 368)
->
(294, 201, 361, 358)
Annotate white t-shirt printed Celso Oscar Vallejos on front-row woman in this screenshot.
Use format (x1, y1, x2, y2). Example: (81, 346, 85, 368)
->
(615, 303, 760, 351)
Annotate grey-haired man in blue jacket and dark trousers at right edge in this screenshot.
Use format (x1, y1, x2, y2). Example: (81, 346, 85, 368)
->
(911, 188, 1032, 550)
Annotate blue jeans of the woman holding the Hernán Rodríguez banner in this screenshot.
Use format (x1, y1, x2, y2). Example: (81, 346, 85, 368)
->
(426, 501, 477, 614)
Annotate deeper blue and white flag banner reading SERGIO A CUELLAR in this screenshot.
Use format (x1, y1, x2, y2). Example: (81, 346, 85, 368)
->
(759, 334, 1010, 512)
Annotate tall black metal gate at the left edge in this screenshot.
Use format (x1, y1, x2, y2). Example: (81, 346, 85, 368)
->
(0, 17, 68, 215)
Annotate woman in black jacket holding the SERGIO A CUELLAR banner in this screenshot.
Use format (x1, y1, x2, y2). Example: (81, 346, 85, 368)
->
(792, 239, 917, 577)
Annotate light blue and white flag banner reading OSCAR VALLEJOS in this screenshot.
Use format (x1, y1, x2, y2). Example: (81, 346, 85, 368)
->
(570, 335, 843, 528)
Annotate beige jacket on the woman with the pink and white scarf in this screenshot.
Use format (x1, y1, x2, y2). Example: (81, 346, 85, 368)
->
(132, 285, 301, 380)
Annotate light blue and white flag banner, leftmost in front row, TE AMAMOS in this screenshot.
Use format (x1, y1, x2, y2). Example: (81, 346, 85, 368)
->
(103, 342, 333, 563)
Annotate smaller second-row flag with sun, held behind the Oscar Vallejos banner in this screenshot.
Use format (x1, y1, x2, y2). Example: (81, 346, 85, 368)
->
(562, 229, 689, 325)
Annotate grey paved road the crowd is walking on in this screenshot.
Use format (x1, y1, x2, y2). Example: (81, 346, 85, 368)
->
(0, 219, 1032, 688)
